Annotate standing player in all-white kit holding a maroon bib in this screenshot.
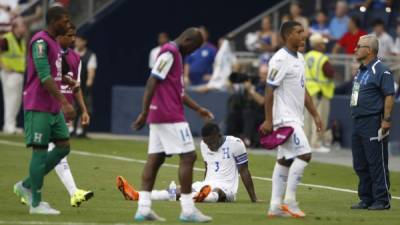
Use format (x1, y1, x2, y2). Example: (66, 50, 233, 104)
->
(261, 21, 322, 217)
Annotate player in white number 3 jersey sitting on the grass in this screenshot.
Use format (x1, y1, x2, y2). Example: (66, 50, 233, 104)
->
(117, 123, 257, 202)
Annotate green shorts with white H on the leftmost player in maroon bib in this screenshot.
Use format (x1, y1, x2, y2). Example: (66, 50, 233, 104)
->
(24, 111, 69, 148)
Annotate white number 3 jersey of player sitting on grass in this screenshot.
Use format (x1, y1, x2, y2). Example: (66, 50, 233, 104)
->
(200, 136, 248, 194)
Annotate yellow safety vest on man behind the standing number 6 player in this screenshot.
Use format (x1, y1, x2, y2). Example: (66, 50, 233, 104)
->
(305, 50, 335, 99)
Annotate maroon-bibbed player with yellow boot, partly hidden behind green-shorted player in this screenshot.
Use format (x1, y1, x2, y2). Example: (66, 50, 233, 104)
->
(49, 25, 94, 207)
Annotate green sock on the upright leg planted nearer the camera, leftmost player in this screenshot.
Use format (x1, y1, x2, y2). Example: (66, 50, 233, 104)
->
(28, 150, 47, 207)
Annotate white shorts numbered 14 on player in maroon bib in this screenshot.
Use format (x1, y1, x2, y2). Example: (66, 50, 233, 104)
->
(148, 122, 195, 155)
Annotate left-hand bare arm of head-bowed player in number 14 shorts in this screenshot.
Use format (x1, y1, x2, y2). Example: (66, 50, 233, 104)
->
(132, 76, 158, 130)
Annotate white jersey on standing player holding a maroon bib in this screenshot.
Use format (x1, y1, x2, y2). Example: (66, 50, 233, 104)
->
(267, 48, 306, 126)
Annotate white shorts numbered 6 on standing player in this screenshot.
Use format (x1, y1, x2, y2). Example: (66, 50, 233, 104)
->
(277, 122, 311, 159)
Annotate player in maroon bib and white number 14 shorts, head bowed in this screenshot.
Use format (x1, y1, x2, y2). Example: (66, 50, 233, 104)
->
(133, 28, 214, 222)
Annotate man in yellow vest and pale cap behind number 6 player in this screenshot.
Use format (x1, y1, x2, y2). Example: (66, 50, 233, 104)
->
(304, 33, 335, 152)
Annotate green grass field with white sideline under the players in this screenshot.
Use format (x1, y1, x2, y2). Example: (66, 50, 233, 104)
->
(0, 135, 400, 225)
